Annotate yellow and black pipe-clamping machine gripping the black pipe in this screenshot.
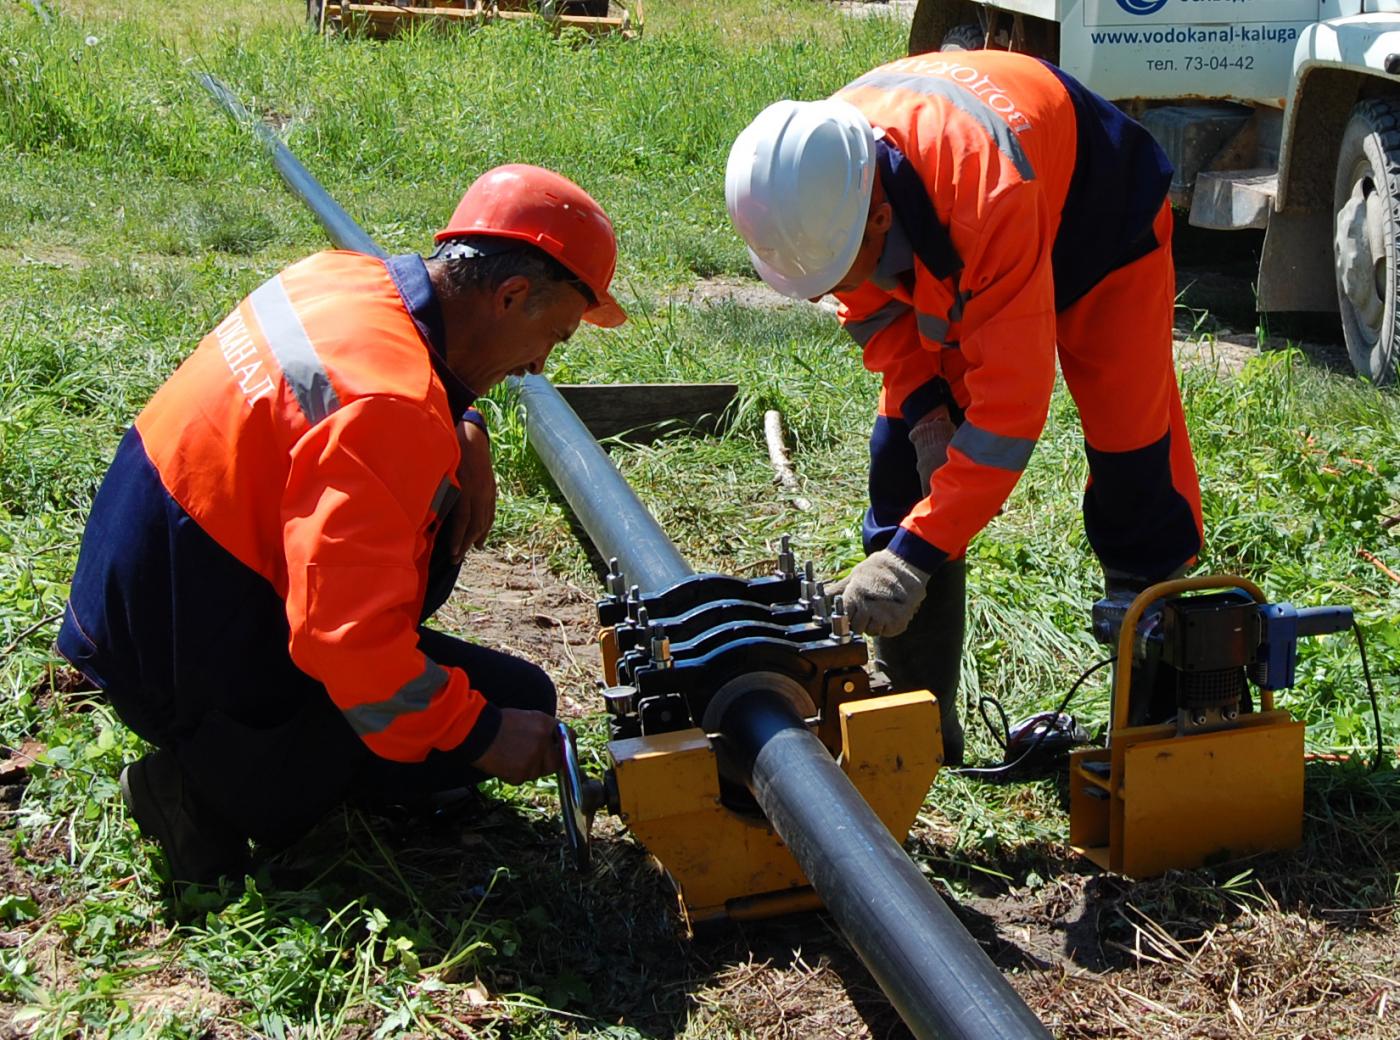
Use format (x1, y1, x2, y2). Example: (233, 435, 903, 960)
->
(561, 540, 942, 924)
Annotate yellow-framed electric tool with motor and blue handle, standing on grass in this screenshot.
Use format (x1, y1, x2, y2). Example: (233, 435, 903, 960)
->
(1070, 577, 1352, 878)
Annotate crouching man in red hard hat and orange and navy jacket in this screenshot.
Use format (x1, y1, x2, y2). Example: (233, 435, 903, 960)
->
(59, 165, 626, 882)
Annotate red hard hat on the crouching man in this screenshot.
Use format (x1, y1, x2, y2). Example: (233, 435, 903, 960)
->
(437, 164, 627, 329)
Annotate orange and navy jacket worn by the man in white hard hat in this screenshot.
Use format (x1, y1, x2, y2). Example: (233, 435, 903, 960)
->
(836, 50, 1170, 568)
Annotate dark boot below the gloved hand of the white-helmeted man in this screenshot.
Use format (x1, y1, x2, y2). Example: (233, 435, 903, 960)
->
(875, 560, 967, 766)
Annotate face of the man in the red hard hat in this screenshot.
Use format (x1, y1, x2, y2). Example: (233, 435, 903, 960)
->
(452, 276, 588, 395)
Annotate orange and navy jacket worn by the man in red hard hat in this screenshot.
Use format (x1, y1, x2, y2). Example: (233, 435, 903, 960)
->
(60, 252, 498, 761)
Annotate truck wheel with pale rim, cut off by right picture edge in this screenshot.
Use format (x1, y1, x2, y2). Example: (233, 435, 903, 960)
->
(1333, 98, 1400, 384)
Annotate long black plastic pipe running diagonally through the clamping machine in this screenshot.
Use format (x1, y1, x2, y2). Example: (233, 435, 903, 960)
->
(200, 74, 1050, 1040)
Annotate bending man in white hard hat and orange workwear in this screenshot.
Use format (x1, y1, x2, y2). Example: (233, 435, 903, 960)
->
(725, 50, 1201, 763)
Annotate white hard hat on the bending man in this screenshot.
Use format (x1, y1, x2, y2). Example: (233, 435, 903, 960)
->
(724, 101, 875, 300)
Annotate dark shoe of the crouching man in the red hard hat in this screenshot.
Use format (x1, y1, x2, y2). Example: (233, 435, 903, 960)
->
(122, 750, 248, 885)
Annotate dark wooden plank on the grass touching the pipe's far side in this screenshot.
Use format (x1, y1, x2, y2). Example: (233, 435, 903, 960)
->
(556, 382, 739, 444)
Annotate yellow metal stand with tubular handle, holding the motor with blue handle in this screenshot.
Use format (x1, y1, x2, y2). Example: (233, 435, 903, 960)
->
(1070, 577, 1303, 878)
